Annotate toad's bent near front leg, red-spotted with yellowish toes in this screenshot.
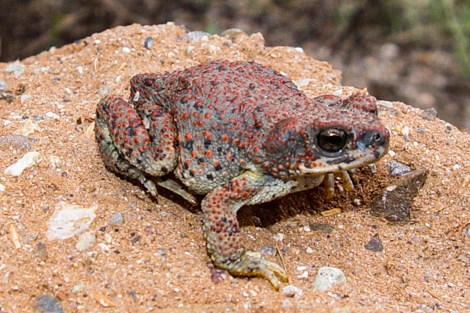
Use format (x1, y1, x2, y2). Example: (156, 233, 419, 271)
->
(202, 171, 297, 290)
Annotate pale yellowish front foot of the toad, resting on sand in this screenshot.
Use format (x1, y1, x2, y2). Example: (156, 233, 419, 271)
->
(227, 251, 288, 290)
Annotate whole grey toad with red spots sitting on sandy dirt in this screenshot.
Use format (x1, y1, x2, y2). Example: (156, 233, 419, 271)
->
(95, 61, 389, 289)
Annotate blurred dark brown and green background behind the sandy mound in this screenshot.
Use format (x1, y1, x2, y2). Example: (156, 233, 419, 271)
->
(0, 0, 470, 131)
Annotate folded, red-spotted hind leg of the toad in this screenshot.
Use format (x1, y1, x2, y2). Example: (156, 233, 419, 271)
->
(95, 96, 177, 196)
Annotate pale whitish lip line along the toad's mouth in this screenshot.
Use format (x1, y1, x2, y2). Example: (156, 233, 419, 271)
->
(298, 146, 388, 175)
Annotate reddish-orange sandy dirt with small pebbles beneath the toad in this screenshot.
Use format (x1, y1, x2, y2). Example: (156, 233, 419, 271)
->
(0, 23, 470, 312)
